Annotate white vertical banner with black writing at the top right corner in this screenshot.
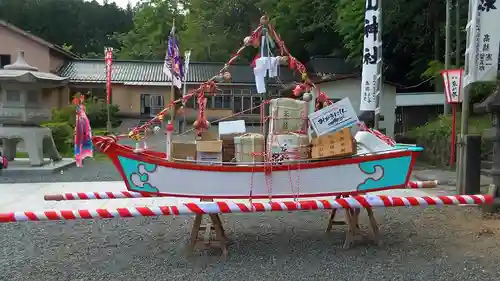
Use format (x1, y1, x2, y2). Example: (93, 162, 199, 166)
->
(464, 0, 500, 86)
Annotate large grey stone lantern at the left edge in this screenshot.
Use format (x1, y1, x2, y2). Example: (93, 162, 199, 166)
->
(0, 51, 67, 166)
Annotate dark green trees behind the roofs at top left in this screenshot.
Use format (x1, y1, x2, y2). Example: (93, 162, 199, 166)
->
(0, 0, 132, 56)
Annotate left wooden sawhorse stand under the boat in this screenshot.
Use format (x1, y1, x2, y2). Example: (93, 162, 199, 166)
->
(188, 199, 229, 257)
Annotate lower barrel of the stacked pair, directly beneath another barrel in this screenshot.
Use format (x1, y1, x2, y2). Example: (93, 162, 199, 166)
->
(267, 133, 311, 162)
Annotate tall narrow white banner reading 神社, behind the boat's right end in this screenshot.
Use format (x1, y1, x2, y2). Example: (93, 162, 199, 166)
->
(359, 0, 382, 111)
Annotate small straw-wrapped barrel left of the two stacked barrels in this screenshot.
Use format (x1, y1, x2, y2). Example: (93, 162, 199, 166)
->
(234, 133, 265, 163)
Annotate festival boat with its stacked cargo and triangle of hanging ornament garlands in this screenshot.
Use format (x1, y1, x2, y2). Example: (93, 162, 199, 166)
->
(93, 16, 420, 199)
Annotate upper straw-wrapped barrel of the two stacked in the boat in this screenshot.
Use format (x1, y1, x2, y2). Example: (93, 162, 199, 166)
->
(269, 98, 308, 134)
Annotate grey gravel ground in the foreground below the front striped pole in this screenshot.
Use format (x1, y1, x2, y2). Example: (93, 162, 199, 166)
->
(0, 207, 500, 281)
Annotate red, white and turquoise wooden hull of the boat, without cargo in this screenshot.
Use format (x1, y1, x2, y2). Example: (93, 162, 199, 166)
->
(94, 137, 418, 198)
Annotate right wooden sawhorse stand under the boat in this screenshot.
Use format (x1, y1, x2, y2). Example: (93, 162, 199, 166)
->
(326, 197, 380, 249)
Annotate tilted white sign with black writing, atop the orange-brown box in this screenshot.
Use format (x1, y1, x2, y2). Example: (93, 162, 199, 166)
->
(308, 98, 359, 136)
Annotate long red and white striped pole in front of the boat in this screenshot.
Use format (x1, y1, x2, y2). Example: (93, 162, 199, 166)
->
(0, 195, 493, 223)
